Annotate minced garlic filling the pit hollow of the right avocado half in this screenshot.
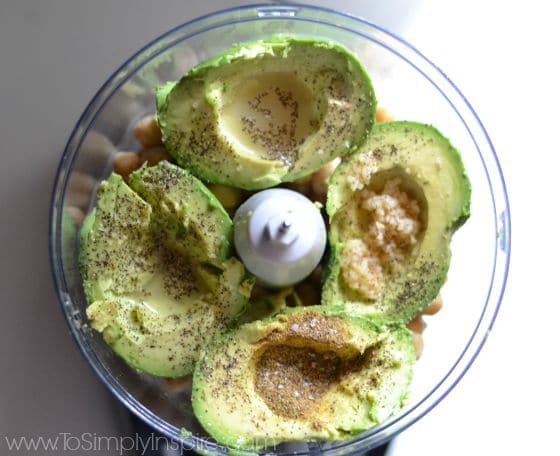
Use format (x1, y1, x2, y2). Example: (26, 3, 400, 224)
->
(341, 176, 423, 299)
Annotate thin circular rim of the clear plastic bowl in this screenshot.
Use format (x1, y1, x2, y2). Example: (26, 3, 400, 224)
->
(49, 3, 511, 455)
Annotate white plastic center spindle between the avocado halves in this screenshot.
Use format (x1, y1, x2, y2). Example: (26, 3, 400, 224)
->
(233, 189, 327, 287)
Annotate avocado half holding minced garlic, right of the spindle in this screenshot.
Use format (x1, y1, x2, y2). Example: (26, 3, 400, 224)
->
(322, 122, 471, 322)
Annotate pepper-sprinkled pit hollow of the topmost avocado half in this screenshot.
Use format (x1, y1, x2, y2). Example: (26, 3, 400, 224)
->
(220, 72, 319, 164)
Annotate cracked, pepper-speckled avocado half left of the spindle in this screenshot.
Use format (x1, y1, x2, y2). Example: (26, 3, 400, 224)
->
(80, 162, 251, 377)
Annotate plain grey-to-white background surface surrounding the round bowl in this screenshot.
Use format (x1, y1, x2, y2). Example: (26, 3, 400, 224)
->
(0, 0, 560, 455)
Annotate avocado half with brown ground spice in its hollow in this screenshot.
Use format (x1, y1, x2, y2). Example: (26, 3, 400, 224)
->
(192, 306, 415, 449)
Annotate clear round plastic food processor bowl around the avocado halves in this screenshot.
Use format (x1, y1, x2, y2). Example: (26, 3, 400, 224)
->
(50, 4, 510, 455)
